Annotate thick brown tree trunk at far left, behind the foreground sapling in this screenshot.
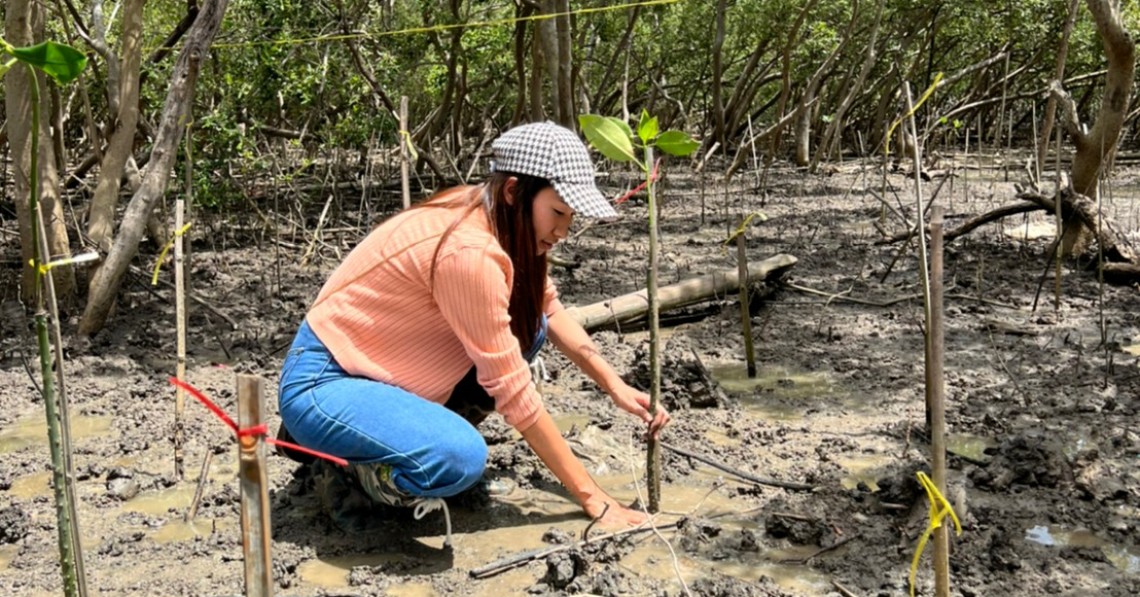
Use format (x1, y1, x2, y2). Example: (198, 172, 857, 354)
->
(5, 0, 75, 304)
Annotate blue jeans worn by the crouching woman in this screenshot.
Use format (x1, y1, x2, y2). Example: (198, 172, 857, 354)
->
(278, 317, 546, 498)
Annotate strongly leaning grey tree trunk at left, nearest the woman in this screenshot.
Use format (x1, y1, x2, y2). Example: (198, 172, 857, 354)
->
(80, 0, 229, 335)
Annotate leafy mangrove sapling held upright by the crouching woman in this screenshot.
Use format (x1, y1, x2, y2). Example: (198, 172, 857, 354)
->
(578, 109, 700, 513)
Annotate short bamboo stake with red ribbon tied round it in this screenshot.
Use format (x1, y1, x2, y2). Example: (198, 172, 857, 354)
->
(237, 374, 274, 597)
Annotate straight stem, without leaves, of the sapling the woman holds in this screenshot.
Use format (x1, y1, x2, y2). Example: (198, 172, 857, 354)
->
(644, 145, 661, 514)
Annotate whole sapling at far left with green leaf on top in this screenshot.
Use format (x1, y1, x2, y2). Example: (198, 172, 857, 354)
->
(0, 39, 87, 597)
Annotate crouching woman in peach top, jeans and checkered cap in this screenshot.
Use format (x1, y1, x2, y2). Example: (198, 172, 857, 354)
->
(279, 122, 669, 535)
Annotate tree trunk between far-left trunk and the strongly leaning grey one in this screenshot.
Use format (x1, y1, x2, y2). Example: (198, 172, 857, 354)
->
(87, 0, 146, 253)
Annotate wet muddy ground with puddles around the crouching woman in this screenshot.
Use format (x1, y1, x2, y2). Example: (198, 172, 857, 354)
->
(0, 160, 1140, 597)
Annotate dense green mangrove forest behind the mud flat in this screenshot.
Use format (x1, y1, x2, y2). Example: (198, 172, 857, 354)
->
(0, 0, 1140, 323)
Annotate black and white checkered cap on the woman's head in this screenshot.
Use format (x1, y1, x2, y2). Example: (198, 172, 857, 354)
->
(491, 122, 618, 218)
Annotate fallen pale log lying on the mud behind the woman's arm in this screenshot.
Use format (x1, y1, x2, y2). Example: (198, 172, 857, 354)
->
(567, 254, 798, 332)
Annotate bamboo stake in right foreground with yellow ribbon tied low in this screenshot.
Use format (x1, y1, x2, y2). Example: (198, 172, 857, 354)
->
(926, 205, 950, 597)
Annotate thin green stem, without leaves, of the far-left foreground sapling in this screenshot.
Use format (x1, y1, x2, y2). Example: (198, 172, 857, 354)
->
(27, 67, 87, 597)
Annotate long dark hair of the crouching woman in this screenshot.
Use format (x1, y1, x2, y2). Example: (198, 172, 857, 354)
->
(413, 172, 551, 352)
